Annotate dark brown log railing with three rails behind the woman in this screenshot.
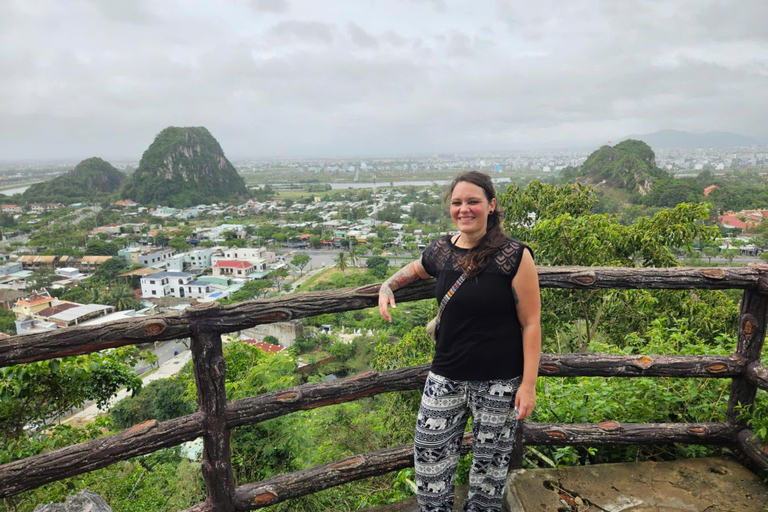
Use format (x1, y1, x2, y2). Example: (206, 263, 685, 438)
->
(0, 265, 768, 511)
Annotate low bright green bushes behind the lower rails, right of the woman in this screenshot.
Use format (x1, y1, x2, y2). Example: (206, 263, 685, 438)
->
(532, 318, 736, 465)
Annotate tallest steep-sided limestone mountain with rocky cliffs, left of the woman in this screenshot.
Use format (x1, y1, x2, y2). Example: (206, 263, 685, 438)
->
(122, 126, 248, 207)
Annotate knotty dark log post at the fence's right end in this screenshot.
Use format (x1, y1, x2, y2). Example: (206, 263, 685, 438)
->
(727, 290, 768, 428)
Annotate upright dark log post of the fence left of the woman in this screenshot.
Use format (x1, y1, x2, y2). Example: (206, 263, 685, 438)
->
(187, 303, 235, 512)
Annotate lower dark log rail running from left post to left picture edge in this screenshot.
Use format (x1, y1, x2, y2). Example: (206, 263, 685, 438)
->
(0, 413, 203, 498)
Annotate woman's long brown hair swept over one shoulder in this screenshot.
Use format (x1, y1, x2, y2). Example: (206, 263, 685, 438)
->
(445, 171, 507, 277)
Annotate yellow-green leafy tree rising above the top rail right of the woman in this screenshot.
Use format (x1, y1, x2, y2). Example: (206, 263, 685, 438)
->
(499, 181, 716, 351)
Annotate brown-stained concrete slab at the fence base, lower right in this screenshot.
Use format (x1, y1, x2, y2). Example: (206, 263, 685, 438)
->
(366, 457, 768, 512)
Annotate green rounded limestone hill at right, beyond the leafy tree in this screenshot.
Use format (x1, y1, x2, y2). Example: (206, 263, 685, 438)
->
(576, 140, 669, 195)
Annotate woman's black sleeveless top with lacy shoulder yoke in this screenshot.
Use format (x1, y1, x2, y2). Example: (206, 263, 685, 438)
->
(421, 236, 530, 380)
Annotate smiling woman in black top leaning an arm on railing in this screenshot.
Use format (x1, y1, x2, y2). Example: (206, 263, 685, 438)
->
(379, 171, 541, 512)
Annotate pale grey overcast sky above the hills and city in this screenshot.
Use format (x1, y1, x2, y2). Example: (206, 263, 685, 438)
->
(0, 0, 768, 160)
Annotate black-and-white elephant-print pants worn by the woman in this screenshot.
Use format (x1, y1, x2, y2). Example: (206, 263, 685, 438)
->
(414, 372, 522, 512)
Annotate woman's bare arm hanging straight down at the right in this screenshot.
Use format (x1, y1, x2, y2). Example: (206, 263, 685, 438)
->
(512, 249, 541, 420)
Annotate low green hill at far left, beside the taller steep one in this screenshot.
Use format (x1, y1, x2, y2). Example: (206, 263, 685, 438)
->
(22, 157, 125, 204)
